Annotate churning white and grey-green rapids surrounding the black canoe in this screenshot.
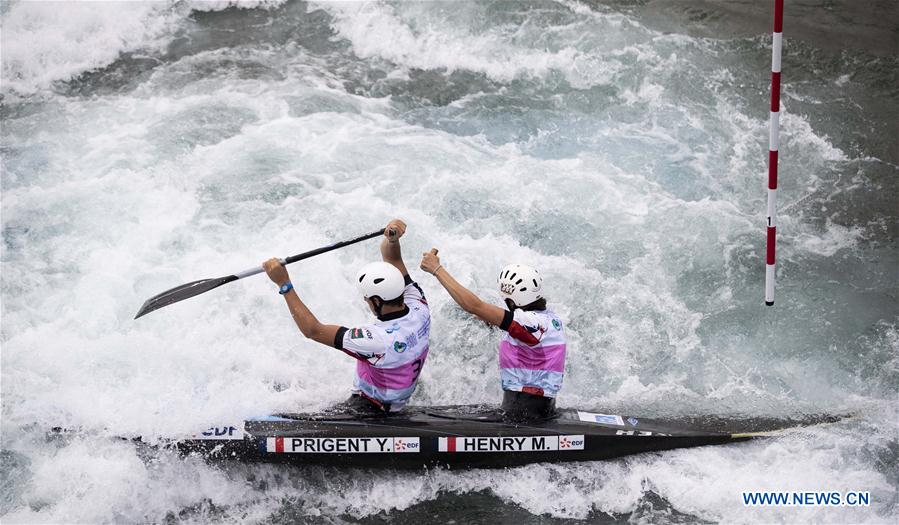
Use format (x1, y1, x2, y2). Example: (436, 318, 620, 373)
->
(0, 1, 899, 523)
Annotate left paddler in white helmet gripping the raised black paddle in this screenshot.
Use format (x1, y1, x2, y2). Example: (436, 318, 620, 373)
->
(263, 219, 431, 414)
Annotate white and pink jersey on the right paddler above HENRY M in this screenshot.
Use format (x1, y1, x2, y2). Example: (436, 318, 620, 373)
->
(499, 309, 565, 397)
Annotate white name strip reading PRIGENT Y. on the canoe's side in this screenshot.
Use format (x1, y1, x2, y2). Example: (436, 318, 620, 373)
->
(265, 437, 421, 454)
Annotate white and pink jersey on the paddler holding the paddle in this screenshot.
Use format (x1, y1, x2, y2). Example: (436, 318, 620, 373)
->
(334, 276, 431, 412)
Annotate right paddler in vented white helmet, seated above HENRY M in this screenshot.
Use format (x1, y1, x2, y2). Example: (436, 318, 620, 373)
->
(421, 249, 565, 419)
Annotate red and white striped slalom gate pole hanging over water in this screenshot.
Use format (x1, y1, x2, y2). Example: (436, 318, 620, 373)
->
(765, 0, 783, 306)
